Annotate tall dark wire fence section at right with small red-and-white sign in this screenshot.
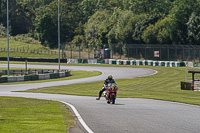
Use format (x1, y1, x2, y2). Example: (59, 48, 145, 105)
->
(127, 44, 200, 61)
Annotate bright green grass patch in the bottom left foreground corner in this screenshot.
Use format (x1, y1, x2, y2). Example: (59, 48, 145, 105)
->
(0, 97, 75, 133)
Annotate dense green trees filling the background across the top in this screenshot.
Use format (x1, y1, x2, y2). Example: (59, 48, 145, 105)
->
(0, 0, 200, 49)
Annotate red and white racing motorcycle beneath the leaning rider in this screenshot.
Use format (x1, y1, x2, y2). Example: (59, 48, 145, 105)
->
(104, 83, 118, 104)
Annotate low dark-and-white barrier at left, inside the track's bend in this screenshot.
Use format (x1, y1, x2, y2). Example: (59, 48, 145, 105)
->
(0, 70, 70, 83)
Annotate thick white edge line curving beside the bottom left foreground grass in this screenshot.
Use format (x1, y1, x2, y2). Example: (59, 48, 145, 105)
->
(59, 101, 94, 133)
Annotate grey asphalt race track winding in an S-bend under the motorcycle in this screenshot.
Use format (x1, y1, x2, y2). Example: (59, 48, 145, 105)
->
(0, 64, 200, 133)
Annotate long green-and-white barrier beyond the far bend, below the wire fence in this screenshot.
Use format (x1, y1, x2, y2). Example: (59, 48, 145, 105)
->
(67, 59, 187, 67)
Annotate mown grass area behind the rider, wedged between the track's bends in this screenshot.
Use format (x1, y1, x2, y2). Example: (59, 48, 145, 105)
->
(23, 66, 200, 105)
